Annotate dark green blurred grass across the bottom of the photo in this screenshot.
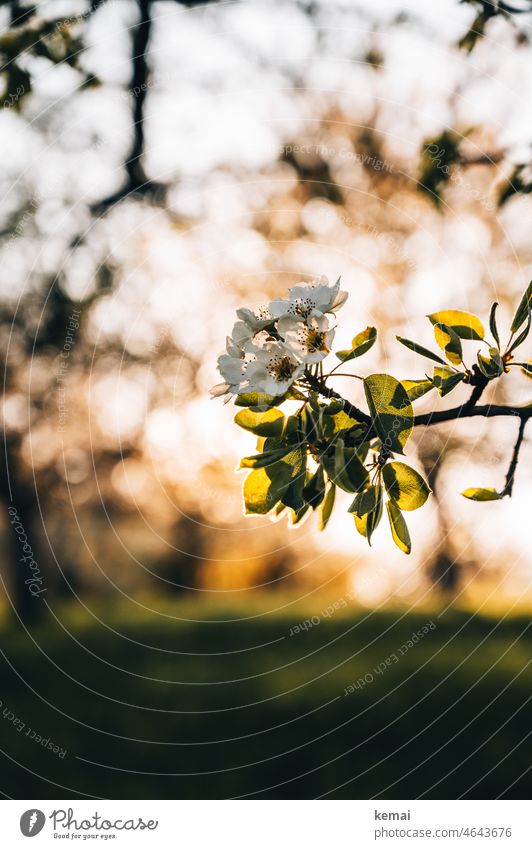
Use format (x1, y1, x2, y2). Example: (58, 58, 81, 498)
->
(0, 605, 532, 799)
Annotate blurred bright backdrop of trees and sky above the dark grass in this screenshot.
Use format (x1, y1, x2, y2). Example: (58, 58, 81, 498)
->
(0, 0, 532, 620)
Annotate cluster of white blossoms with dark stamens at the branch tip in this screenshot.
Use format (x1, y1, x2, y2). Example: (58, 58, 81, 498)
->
(211, 277, 347, 399)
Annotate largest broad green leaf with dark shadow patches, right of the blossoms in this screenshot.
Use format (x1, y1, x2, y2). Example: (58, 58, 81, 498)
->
(364, 374, 414, 454)
